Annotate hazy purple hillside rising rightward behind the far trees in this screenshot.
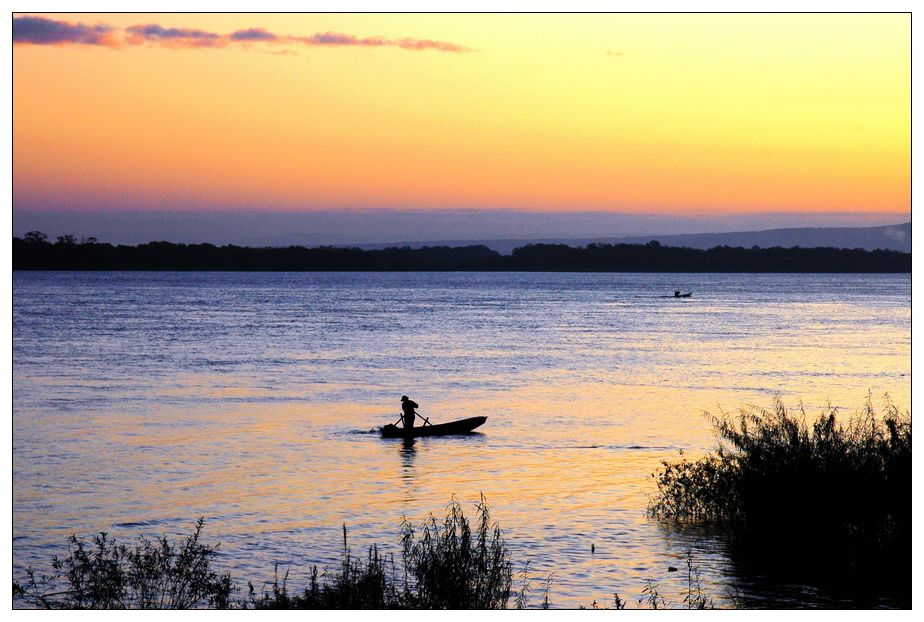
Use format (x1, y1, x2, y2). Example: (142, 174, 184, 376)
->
(358, 222, 911, 254)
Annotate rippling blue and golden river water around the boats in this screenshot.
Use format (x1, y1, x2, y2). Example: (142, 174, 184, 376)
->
(13, 272, 911, 606)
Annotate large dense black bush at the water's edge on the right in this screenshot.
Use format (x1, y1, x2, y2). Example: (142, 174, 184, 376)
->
(649, 396, 911, 576)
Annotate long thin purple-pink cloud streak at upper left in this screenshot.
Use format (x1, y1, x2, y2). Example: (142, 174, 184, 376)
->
(13, 17, 471, 53)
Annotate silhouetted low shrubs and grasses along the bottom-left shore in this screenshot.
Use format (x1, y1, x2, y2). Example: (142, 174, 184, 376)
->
(13, 496, 516, 609)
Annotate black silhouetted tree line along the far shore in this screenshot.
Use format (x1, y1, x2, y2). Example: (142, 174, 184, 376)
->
(13, 231, 911, 273)
